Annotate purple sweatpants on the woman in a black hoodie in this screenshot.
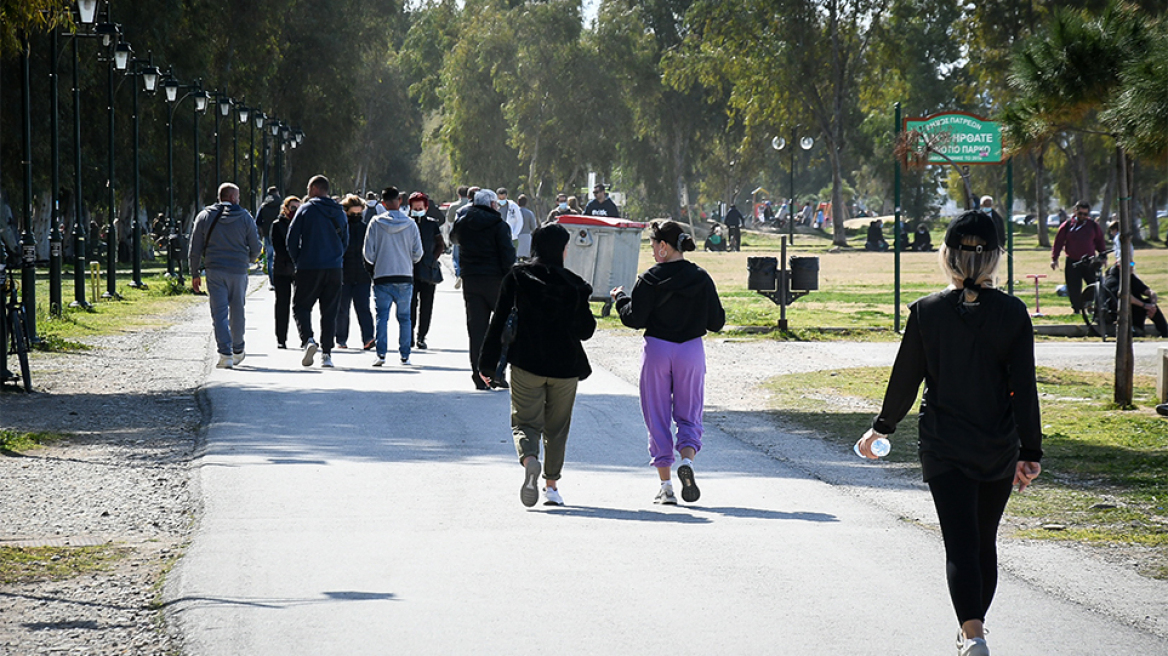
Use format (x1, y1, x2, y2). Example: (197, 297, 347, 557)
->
(641, 337, 705, 467)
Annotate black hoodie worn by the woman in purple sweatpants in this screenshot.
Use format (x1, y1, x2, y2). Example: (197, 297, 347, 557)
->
(617, 259, 726, 344)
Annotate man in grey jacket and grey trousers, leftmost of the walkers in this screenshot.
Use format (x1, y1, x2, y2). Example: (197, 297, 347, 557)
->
(187, 182, 260, 369)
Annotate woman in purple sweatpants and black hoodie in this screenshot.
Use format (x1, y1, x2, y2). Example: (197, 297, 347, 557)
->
(612, 221, 726, 504)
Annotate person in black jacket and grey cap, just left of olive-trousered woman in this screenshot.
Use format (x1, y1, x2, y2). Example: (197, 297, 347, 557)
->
(450, 189, 515, 390)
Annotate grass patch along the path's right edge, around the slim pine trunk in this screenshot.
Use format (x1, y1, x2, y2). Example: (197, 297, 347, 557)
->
(769, 368, 1168, 578)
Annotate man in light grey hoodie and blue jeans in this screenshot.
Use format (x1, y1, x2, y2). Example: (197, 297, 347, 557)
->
(364, 187, 422, 367)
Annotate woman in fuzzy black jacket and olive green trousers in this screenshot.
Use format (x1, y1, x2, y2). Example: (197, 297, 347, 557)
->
(479, 223, 596, 507)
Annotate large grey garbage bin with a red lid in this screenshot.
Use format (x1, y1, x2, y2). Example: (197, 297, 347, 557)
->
(556, 215, 645, 316)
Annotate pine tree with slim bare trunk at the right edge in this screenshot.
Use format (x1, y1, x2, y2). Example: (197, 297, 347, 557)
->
(1001, 0, 1144, 406)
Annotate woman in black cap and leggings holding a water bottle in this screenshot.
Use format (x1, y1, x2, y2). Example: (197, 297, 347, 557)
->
(858, 211, 1042, 656)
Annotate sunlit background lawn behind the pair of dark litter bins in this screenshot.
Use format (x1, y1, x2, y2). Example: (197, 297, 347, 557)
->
(595, 222, 1168, 340)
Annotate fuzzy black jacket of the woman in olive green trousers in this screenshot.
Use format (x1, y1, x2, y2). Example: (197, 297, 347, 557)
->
(479, 260, 596, 381)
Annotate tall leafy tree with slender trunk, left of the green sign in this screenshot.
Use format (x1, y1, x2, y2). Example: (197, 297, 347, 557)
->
(670, 0, 887, 245)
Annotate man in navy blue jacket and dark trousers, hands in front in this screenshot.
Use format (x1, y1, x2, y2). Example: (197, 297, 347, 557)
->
(287, 175, 349, 367)
